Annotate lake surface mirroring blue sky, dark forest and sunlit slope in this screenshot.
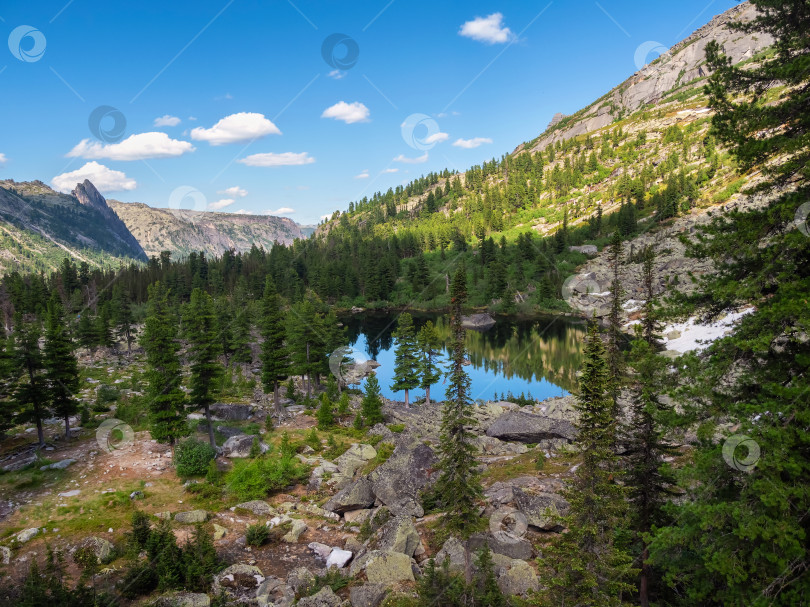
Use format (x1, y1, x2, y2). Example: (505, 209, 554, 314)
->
(342, 313, 585, 401)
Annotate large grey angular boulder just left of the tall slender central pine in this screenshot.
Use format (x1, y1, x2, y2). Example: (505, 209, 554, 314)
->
(369, 443, 437, 517)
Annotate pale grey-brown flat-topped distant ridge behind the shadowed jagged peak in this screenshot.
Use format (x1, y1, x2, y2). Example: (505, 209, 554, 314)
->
(110, 200, 305, 257)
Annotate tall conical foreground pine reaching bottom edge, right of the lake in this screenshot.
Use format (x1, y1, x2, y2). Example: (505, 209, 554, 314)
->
(543, 325, 637, 607)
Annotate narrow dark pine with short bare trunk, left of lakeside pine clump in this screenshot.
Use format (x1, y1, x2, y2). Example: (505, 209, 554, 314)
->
(260, 276, 290, 419)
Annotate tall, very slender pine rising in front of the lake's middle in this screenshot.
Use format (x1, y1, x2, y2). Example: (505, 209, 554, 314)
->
(433, 266, 483, 533)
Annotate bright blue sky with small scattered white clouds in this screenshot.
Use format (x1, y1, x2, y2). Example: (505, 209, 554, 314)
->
(0, 0, 736, 223)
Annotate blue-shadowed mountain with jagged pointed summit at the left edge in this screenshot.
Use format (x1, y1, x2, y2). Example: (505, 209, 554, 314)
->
(0, 180, 146, 271)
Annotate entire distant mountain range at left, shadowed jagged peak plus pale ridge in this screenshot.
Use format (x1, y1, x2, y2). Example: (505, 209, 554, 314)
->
(0, 180, 314, 272)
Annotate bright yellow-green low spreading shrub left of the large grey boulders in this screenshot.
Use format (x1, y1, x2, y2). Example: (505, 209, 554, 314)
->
(225, 453, 308, 502)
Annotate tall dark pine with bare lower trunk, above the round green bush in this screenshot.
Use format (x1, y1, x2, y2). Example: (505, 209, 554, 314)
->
(183, 288, 222, 448)
